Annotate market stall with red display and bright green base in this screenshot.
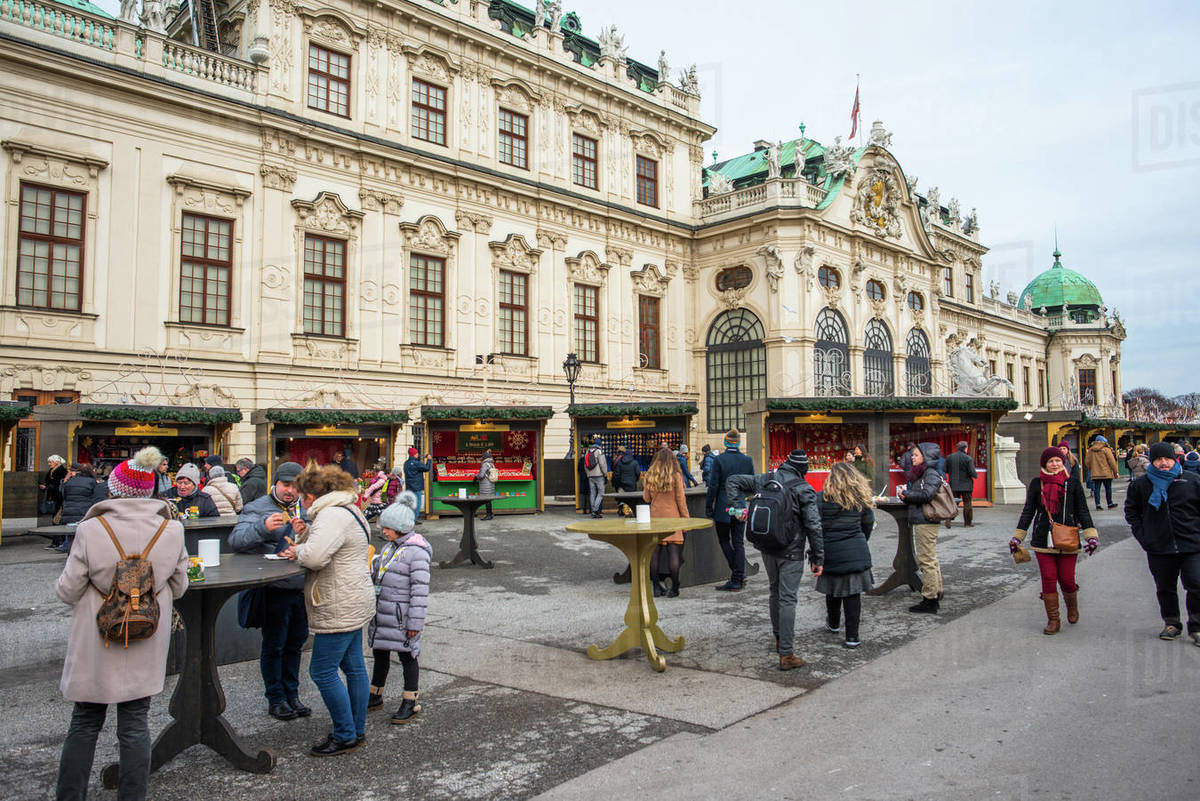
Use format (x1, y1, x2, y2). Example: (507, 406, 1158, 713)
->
(421, 405, 554, 516)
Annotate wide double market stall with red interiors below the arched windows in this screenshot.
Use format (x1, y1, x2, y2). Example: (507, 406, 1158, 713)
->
(745, 397, 1016, 499)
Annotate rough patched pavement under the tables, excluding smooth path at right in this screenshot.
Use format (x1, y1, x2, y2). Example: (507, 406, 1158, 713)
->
(0, 489, 1128, 801)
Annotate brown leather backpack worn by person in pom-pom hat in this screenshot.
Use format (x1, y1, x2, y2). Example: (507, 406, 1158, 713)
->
(92, 516, 169, 648)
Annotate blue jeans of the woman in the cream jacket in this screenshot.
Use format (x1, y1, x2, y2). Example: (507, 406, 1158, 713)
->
(308, 628, 371, 742)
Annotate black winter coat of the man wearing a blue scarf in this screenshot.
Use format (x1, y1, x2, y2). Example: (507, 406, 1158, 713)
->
(1126, 470, 1200, 554)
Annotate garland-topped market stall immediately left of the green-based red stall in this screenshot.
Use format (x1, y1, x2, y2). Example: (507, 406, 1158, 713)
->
(250, 409, 408, 476)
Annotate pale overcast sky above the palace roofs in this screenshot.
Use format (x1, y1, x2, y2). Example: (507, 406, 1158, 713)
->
(101, 0, 1200, 395)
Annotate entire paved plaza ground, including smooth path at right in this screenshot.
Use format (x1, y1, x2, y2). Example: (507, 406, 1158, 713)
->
(0, 484, 1200, 801)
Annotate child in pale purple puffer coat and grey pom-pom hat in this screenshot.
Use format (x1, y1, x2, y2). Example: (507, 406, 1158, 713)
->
(367, 492, 433, 723)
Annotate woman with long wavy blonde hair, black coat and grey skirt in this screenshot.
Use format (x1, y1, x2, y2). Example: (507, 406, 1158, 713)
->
(817, 462, 875, 648)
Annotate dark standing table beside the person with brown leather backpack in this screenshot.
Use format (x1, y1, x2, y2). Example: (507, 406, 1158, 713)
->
(100, 554, 304, 789)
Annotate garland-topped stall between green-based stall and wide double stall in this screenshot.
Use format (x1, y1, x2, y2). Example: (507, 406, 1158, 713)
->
(568, 402, 700, 508)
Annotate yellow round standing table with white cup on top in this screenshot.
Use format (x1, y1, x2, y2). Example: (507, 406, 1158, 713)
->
(566, 517, 713, 673)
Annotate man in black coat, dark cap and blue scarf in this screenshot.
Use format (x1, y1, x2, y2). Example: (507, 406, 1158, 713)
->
(1124, 442, 1200, 645)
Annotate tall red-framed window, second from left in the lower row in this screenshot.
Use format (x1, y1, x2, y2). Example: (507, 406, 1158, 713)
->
(179, 213, 233, 325)
